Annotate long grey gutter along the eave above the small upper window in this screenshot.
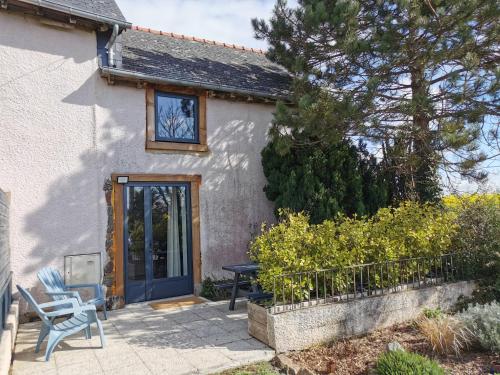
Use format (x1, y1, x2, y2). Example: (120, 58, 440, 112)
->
(100, 66, 290, 101)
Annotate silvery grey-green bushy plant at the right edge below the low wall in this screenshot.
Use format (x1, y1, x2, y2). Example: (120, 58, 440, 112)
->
(456, 302, 500, 353)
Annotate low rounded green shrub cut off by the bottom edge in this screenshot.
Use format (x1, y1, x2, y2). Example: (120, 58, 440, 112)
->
(375, 350, 445, 375)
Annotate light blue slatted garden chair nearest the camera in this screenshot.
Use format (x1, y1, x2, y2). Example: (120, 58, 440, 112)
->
(16, 285, 106, 361)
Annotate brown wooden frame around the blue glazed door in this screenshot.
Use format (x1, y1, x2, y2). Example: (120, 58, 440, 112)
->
(111, 173, 201, 303)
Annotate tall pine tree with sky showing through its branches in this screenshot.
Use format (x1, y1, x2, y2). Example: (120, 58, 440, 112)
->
(253, 0, 500, 201)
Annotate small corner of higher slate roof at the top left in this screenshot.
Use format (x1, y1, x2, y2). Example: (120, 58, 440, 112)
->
(20, 0, 127, 23)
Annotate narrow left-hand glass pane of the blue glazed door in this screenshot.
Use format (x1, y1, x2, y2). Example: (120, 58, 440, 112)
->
(127, 187, 146, 280)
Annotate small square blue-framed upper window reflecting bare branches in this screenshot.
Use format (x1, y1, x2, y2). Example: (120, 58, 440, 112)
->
(155, 91, 199, 143)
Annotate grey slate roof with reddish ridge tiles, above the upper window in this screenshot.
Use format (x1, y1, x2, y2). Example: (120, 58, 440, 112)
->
(121, 27, 291, 97)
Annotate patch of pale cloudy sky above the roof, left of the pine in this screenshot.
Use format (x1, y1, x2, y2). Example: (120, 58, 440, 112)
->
(117, 0, 296, 49)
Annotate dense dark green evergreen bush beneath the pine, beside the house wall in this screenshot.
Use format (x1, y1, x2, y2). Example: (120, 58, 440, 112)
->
(262, 134, 388, 223)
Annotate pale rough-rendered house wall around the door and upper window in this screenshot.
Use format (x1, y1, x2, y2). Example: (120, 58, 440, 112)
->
(0, 11, 274, 312)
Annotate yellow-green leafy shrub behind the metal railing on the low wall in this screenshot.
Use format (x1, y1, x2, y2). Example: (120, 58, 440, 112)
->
(250, 202, 456, 299)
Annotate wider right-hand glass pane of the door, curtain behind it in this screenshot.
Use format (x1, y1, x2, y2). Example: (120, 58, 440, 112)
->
(151, 186, 188, 279)
